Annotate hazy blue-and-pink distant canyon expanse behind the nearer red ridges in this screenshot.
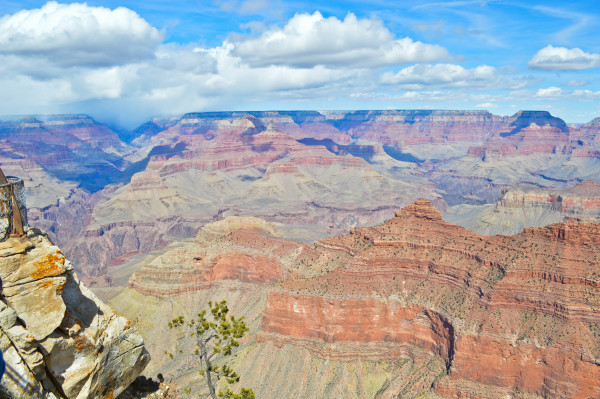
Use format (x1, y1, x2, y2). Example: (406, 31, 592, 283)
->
(0, 110, 600, 282)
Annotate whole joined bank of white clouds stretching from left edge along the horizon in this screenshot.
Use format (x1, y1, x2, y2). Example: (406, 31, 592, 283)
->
(0, 0, 600, 126)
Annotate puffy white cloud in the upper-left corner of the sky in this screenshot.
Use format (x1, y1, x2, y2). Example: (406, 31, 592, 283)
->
(0, 1, 163, 66)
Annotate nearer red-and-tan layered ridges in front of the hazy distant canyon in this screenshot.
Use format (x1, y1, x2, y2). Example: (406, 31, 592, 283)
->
(119, 201, 600, 399)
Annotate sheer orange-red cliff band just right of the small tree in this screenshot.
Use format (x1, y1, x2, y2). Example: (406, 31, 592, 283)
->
(262, 292, 454, 364)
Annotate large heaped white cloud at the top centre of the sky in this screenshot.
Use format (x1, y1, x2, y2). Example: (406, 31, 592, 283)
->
(229, 11, 449, 68)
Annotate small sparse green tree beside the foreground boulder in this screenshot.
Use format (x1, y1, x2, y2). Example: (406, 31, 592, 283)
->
(166, 300, 255, 399)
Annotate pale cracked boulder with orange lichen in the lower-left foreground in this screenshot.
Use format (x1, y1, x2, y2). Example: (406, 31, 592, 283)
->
(0, 230, 150, 399)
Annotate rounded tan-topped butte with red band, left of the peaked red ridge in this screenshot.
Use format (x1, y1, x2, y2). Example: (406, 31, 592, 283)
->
(129, 217, 306, 297)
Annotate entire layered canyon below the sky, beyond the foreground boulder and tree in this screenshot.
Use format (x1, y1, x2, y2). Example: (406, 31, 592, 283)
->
(0, 110, 600, 399)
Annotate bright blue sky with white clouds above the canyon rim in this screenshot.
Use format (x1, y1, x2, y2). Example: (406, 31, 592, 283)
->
(0, 0, 600, 128)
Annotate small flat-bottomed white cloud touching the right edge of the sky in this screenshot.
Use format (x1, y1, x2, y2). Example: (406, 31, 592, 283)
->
(527, 45, 600, 71)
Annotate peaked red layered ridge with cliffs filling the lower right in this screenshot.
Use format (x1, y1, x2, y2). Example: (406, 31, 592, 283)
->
(262, 201, 600, 398)
